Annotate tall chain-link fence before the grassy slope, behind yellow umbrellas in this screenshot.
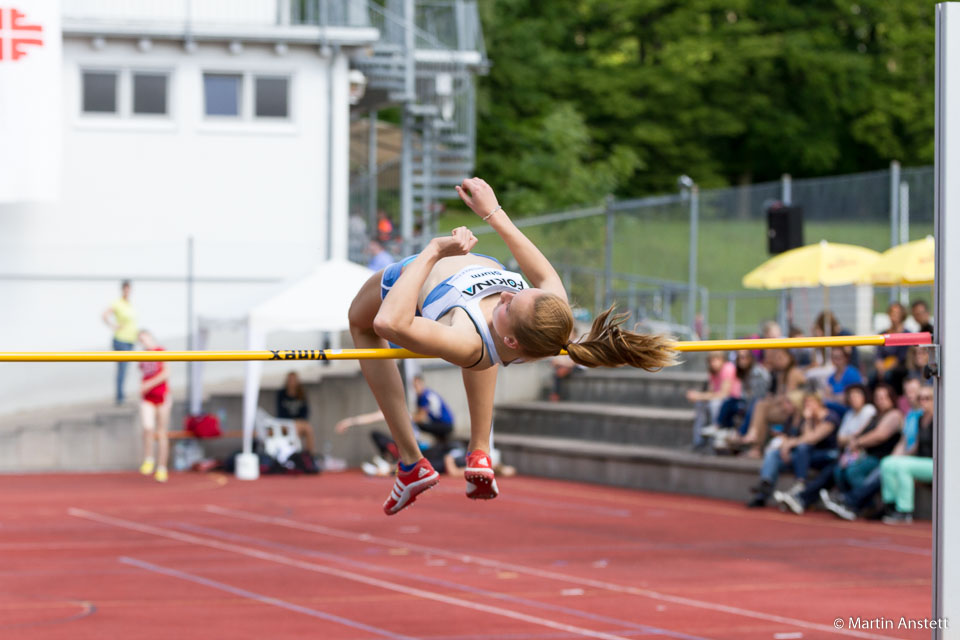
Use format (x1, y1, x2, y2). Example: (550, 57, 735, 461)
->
(350, 164, 933, 338)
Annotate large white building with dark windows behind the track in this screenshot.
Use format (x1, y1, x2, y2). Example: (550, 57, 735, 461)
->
(0, 0, 380, 411)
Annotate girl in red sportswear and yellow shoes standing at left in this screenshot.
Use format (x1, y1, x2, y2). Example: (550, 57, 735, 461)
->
(139, 330, 173, 482)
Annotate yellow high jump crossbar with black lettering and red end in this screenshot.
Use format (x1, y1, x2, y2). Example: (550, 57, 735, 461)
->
(0, 333, 930, 362)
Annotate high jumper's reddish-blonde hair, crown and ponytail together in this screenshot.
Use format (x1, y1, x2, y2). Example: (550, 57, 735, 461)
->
(514, 293, 676, 371)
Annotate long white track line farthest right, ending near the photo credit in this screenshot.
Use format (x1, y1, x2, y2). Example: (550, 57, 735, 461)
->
(204, 505, 894, 640)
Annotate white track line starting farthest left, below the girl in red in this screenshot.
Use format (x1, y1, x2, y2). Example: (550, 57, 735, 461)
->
(67, 507, 626, 640)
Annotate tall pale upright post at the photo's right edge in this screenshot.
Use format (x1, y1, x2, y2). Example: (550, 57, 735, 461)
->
(933, 2, 960, 639)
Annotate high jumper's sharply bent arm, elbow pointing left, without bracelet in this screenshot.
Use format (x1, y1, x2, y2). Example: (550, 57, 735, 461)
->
(373, 227, 483, 367)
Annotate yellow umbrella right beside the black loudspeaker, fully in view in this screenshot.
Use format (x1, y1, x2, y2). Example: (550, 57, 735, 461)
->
(742, 240, 880, 289)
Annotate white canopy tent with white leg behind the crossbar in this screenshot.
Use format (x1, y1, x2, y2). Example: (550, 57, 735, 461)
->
(194, 259, 373, 478)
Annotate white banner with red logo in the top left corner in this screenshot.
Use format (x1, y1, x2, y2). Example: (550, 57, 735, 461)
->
(0, 0, 63, 203)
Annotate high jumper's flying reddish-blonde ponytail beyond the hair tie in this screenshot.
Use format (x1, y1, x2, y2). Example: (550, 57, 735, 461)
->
(566, 306, 677, 371)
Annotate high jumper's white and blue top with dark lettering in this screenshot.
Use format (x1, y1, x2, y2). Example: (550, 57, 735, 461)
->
(420, 266, 530, 364)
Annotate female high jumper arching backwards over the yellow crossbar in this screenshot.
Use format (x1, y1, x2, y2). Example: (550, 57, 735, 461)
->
(350, 178, 675, 515)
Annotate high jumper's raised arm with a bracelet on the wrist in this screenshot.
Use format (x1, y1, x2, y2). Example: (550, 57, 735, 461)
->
(457, 178, 567, 300)
